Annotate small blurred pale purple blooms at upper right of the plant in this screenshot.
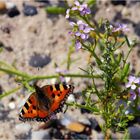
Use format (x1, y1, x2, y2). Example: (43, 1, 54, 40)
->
(112, 24, 129, 32)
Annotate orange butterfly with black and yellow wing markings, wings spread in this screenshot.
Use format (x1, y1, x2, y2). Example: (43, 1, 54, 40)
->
(19, 84, 74, 122)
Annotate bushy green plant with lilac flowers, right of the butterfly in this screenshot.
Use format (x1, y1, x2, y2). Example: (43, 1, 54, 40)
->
(66, 1, 140, 139)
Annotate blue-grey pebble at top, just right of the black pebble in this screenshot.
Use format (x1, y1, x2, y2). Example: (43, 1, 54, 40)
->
(23, 3, 38, 16)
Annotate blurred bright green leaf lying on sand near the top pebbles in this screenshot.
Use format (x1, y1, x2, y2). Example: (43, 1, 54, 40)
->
(45, 6, 66, 14)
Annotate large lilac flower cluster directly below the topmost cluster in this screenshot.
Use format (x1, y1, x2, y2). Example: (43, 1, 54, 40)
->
(70, 20, 94, 50)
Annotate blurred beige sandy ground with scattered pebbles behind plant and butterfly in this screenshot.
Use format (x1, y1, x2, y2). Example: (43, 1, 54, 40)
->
(0, 0, 140, 140)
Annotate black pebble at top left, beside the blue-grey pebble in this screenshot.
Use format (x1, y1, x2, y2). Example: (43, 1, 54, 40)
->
(7, 7, 20, 18)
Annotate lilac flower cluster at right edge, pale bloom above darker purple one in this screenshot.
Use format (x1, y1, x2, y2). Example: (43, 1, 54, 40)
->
(126, 76, 140, 100)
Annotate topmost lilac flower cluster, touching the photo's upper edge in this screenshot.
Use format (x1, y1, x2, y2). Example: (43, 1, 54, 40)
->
(66, 1, 91, 19)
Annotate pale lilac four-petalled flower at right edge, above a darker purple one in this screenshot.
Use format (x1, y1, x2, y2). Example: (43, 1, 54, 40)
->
(126, 76, 140, 90)
